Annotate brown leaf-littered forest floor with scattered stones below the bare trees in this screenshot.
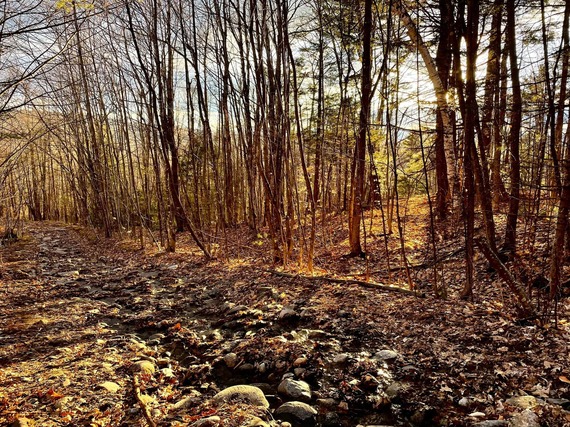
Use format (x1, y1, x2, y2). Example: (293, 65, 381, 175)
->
(0, 206, 570, 427)
